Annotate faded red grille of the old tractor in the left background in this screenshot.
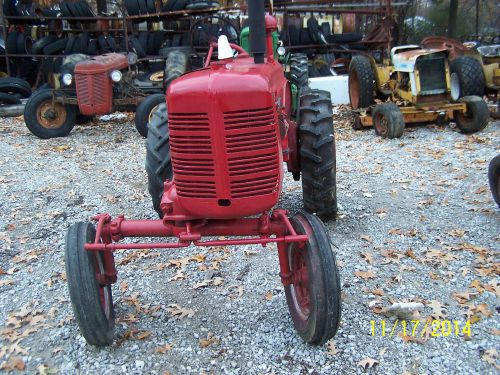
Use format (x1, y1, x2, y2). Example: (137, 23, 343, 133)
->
(75, 73, 109, 107)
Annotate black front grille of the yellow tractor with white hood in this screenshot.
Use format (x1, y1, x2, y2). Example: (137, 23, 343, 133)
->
(416, 53, 446, 95)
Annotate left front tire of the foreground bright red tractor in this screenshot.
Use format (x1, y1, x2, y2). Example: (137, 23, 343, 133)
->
(64, 222, 115, 346)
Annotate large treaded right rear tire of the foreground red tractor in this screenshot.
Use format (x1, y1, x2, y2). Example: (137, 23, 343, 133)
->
(299, 88, 337, 220)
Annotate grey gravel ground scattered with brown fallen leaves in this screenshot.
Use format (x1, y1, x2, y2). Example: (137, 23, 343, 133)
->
(0, 109, 500, 374)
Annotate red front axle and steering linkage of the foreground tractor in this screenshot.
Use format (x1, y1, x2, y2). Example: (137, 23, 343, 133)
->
(84, 209, 309, 285)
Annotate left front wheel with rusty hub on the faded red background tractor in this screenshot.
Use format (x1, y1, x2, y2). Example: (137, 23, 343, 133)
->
(24, 89, 76, 139)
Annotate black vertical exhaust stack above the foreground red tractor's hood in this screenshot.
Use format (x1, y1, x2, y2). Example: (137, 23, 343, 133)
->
(248, 0, 266, 64)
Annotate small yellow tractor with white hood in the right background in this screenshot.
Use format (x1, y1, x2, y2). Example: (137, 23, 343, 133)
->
(349, 45, 489, 138)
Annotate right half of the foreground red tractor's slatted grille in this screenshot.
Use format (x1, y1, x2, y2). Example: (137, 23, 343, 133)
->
(224, 107, 279, 198)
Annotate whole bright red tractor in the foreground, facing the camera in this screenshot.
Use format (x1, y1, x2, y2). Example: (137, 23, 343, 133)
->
(65, 0, 341, 346)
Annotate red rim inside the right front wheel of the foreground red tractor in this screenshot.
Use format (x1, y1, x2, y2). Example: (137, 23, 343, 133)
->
(289, 246, 311, 320)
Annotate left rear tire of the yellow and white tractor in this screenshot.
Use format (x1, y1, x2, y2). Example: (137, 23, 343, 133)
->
(349, 55, 375, 109)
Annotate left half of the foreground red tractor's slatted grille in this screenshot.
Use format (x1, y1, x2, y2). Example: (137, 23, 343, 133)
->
(168, 113, 216, 198)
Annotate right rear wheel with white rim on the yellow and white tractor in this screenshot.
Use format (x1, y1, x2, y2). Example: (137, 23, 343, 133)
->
(450, 56, 486, 100)
